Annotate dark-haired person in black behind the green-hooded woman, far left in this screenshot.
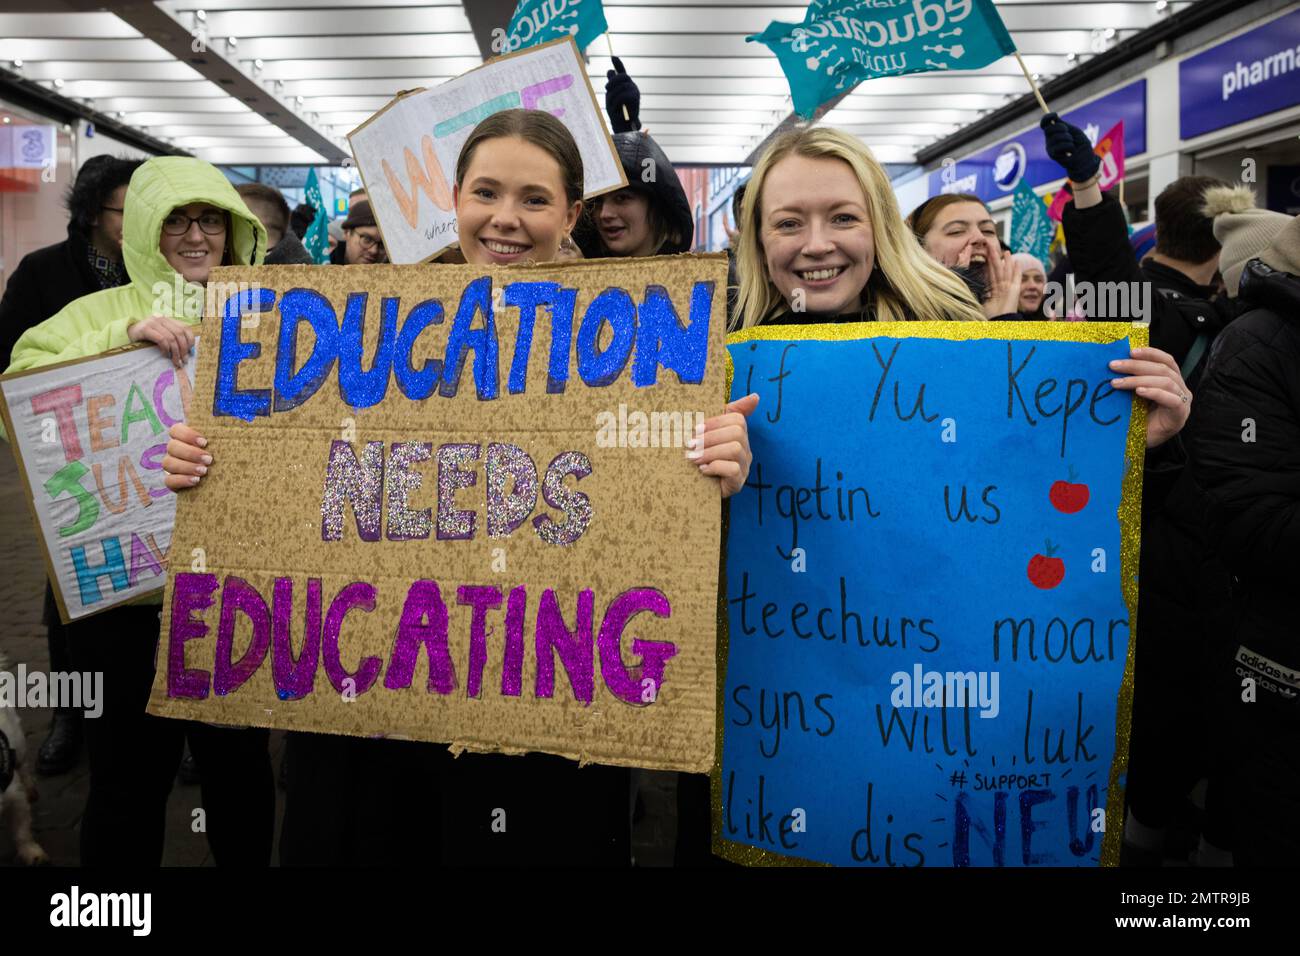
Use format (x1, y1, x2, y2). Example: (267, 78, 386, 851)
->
(0, 155, 143, 777)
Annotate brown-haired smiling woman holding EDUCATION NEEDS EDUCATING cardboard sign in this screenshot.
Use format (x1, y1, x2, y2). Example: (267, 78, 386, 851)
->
(164, 111, 757, 866)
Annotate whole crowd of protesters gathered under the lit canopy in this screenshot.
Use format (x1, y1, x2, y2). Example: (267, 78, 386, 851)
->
(0, 61, 1300, 866)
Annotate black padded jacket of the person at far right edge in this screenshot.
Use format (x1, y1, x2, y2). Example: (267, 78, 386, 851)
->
(1188, 263, 1300, 702)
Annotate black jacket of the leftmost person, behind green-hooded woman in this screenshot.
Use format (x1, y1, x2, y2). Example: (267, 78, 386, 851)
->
(0, 229, 111, 372)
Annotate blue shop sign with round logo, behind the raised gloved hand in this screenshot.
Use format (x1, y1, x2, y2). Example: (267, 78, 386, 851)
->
(925, 79, 1147, 204)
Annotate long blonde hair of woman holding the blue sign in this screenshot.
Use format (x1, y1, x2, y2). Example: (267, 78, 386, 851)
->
(736, 126, 985, 328)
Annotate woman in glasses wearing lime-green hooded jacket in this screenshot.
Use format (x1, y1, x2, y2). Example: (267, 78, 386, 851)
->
(9, 156, 276, 866)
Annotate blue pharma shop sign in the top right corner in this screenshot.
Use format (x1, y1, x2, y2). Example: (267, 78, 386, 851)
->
(1178, 10, 1300, 139)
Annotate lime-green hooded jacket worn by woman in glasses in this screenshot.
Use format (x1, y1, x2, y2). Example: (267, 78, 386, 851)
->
(8, 156, 267, 372)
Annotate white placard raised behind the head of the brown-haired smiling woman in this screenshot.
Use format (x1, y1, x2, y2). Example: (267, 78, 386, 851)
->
(348, 38, 628, 263)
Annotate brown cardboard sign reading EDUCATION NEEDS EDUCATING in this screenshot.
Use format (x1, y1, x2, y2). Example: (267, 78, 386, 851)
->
(150, 256, 727, 771)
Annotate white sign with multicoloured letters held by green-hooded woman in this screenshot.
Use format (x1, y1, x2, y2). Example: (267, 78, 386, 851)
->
(0, 345, 194, 623)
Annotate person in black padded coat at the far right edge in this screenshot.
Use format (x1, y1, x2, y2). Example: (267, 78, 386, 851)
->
(1188, 219, 1300, 866)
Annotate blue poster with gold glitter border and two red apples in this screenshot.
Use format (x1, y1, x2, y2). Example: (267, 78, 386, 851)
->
(714, 323, 1147, 866)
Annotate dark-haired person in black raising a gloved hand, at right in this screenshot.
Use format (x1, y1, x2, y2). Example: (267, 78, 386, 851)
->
(1041, 113, 1235, 866)
